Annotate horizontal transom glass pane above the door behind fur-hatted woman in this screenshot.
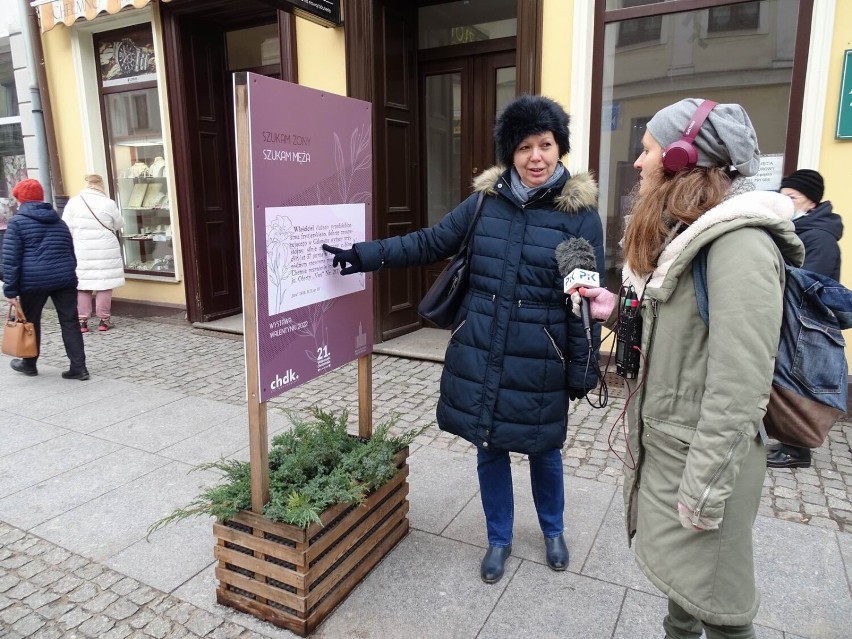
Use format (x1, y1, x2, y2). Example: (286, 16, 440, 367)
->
(418, 0, 518, 49)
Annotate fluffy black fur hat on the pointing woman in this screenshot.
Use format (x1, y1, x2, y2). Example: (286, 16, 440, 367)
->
(494, 95, 571, 167)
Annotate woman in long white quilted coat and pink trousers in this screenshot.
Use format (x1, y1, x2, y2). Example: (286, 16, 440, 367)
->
(62, 175, 124, 333)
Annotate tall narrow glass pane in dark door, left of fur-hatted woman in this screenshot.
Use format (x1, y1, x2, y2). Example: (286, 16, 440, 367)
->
(424, 73, 462, 226)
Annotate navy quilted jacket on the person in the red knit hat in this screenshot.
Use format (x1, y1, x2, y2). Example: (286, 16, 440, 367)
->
(3, 202, 77, 298)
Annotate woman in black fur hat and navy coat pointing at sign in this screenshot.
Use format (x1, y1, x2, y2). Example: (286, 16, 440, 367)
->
(323, 95, 604, 583)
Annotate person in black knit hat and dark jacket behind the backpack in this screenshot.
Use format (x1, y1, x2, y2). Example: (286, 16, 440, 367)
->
(766, 169, 843, 468)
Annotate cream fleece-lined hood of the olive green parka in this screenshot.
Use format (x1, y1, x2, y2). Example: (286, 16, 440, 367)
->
(624, 184, 805, 299)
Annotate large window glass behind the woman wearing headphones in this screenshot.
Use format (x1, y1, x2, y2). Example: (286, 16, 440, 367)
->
(598, 0, 799, 286)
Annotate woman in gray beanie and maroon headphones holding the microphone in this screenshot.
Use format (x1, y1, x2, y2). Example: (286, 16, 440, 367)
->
(578, 99, 804, 639)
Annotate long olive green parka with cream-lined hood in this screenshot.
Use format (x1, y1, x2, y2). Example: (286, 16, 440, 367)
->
(612, 179, 804, 625)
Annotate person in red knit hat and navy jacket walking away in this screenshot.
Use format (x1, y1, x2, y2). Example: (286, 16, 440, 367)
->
(3, 180, 89, 380)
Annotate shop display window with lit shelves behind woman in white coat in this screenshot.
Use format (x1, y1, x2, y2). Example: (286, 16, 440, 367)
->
(93, 23, 175, 277)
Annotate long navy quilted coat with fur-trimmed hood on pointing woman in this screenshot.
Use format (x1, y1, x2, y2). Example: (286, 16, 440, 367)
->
(355, 167, 604, 454)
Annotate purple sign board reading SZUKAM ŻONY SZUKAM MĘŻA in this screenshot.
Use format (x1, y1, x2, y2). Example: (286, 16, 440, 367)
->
(236, 73, 373, 402)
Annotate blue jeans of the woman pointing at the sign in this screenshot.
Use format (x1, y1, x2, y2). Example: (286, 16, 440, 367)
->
(476, 448, 565, 547)
